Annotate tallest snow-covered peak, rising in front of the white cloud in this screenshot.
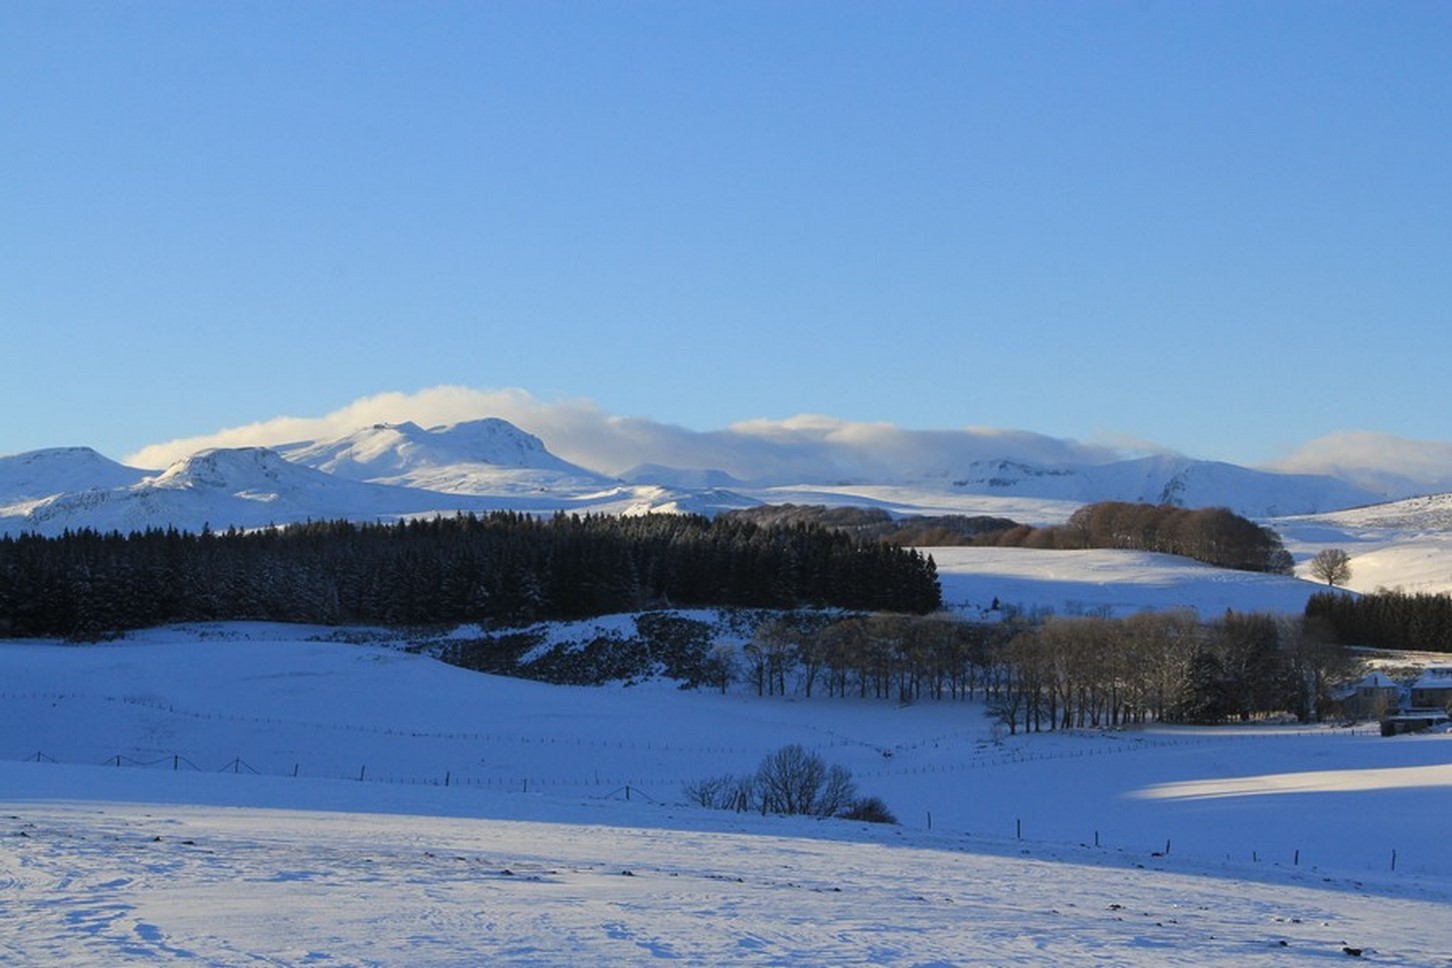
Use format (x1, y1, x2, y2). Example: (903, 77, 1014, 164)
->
(277, 418, 611, 495)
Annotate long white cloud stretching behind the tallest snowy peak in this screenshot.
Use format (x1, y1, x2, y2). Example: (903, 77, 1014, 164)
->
(125, 386, 1124, 482)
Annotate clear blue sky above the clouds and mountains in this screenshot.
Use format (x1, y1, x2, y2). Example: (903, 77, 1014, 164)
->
(0, 0, 1452, 463)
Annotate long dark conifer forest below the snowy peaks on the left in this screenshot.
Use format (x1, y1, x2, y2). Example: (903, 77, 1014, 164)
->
(0, 512, 941, 637)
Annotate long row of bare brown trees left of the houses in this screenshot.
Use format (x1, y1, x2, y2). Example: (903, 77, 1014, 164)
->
(738, 611, 1350, 733)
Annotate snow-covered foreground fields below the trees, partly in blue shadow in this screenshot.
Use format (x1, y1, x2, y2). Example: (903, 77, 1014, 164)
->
(0, 625, 1452, 965)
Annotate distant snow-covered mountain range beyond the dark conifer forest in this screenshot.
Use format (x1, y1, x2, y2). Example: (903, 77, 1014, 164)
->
(0, 418, 1428, 534)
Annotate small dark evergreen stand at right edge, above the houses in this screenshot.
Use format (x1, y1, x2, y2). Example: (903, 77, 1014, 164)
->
(1305, 592, 1452, 652)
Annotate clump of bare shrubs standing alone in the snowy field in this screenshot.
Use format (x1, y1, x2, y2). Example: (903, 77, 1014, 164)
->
(684, 743, 897, 823)
